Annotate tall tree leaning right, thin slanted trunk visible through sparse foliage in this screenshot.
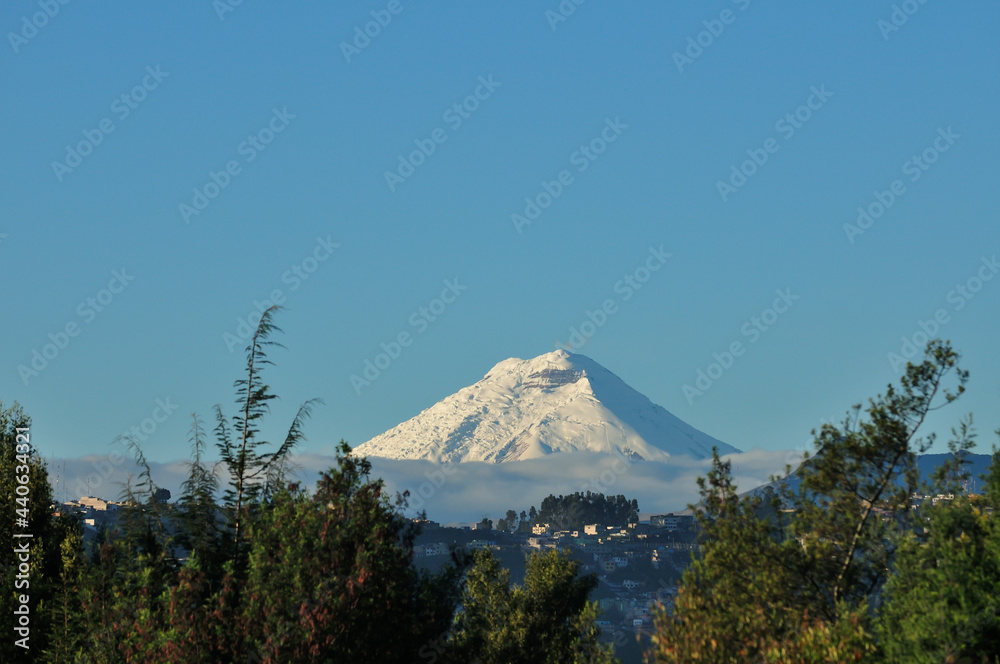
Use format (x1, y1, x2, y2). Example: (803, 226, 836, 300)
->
(785, 341, 968, 620)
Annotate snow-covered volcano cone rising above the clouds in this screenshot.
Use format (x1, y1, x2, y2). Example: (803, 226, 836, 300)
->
(355, 350, 739, 463)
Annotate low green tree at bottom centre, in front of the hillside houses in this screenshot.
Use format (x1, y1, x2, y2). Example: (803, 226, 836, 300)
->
(447, 549, 617, 664)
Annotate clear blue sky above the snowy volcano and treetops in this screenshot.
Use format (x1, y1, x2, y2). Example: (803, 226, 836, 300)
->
(0, 0, 1000, 461)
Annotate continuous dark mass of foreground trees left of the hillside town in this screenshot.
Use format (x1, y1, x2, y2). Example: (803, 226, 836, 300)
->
(0, 311, 614, 664)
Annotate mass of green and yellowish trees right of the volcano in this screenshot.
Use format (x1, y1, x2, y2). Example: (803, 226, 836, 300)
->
(652, 342, 1000, 664)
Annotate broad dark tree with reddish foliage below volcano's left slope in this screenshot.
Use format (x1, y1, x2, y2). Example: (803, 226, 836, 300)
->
(242, 442, 462, 663)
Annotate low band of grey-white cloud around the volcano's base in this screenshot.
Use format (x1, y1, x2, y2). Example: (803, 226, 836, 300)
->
(49, 450, 794, 523)
